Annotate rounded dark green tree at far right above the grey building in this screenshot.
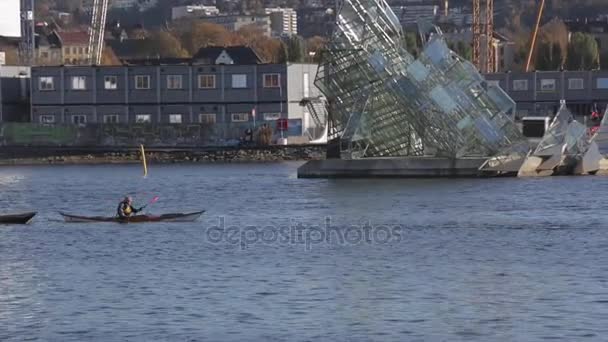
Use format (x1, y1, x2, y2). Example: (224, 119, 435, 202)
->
(566, 32, 600, 70)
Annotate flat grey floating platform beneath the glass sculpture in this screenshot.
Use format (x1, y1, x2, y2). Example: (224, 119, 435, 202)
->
(298, 157, 487, 178)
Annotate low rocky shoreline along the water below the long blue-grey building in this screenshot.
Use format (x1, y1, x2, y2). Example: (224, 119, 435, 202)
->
(0, 145, 326, 165)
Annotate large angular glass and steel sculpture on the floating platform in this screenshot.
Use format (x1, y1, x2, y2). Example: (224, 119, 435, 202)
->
(315, 0, 528, 163)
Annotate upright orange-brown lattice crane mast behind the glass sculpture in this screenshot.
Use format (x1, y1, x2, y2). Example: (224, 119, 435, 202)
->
(472, 0, 496, 73)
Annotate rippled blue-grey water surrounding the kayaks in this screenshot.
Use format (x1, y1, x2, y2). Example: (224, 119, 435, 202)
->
(0, 164, 608, 341)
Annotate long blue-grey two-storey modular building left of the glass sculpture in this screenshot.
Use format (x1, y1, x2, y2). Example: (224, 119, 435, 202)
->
(31, 63, 319, 140)
